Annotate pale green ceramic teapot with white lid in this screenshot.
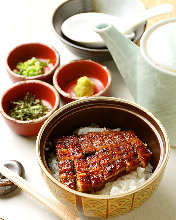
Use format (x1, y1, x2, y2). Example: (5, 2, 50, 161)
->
(94, 18, 176, 146)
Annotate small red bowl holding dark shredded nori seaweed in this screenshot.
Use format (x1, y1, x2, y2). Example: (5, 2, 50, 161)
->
(0, 80, 60, 136)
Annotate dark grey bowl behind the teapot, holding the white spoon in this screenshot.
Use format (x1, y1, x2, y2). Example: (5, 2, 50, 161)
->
(52, 0, 145, 61)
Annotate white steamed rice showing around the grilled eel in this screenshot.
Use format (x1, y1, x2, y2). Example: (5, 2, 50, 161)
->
(48, 125, 152, 195)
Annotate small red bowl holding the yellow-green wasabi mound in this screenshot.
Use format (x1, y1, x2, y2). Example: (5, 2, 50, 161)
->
(53, 60, 112, 103)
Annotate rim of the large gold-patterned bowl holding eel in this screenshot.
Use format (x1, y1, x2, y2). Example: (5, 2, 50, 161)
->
(36, 97, 170, 199)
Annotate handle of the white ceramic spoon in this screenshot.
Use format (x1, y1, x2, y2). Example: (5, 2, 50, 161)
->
(123, 4, 173, 33)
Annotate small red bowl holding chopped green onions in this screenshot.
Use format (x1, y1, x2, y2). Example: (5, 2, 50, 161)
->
(6, 43, 60, 83)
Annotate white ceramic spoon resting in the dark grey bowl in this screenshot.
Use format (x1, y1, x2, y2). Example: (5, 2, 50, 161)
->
(61, 4, 173, 48)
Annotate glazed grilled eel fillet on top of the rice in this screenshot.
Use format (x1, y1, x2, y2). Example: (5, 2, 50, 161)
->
(55, 129, 152, 193)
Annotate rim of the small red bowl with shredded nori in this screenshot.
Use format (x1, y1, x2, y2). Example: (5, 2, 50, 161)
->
(0, 80, 60, 124)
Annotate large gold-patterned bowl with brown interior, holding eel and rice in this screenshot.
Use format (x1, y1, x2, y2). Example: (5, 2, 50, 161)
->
(36, 97, 169, 218)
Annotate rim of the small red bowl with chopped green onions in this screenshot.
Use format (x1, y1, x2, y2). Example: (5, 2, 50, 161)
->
(6, 42, 60, 80)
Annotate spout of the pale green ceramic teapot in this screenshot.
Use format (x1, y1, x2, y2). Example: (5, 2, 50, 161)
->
(94, 23, 139, 100)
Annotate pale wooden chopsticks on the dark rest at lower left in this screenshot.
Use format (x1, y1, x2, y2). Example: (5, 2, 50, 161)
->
(0, 164, 81, 220)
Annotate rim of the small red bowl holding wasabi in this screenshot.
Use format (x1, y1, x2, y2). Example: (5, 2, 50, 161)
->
(53, 59, 112, 101)
